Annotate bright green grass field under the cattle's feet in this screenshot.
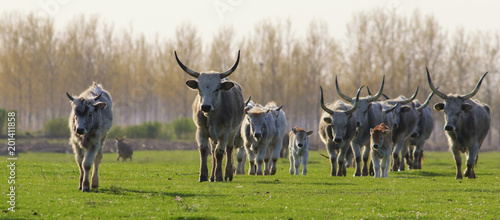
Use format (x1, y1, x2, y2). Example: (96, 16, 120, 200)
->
(0, 151, 500, 219)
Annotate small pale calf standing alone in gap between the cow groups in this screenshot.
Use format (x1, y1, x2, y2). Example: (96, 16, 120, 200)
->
(288, 127, 313, 175)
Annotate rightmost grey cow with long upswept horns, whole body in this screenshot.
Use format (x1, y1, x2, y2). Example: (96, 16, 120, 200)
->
(427, 69, 491, 179)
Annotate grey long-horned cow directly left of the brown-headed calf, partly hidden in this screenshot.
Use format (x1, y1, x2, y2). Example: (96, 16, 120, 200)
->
(335, 76, 385, 176)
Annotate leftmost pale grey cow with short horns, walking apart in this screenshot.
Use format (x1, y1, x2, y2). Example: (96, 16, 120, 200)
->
(66, 82, 113, 192)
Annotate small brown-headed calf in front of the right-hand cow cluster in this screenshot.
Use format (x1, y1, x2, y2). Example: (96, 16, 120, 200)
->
(370, 123, 392, 178)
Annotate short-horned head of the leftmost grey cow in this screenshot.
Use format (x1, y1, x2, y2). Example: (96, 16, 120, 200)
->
(66, 93, 106, 135)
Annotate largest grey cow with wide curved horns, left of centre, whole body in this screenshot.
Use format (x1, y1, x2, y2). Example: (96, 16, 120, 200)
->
(174, 51, 244, 182)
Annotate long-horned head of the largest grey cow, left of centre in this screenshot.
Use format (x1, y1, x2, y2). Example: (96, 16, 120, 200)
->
(174, 51, 240, 114)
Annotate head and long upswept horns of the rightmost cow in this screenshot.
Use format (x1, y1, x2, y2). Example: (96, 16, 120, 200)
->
(425, 67, 488, 131)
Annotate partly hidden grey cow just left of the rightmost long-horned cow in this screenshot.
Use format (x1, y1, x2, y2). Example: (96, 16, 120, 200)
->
(408, 92, 434, 169)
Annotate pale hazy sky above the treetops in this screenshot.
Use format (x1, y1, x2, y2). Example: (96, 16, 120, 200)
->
(0, 0, 500, 41)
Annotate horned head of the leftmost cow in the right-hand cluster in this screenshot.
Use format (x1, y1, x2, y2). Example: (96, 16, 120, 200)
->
(319, 86, 363, 143)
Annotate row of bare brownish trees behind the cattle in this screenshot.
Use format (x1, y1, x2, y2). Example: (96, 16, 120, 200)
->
(0, 8, 500, 150)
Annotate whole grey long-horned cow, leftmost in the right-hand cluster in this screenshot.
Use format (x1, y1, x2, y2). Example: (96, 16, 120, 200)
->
(318, 86, 363, 176)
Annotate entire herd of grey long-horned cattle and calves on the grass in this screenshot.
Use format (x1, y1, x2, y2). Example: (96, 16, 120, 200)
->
(66, 51, 490, 192)
